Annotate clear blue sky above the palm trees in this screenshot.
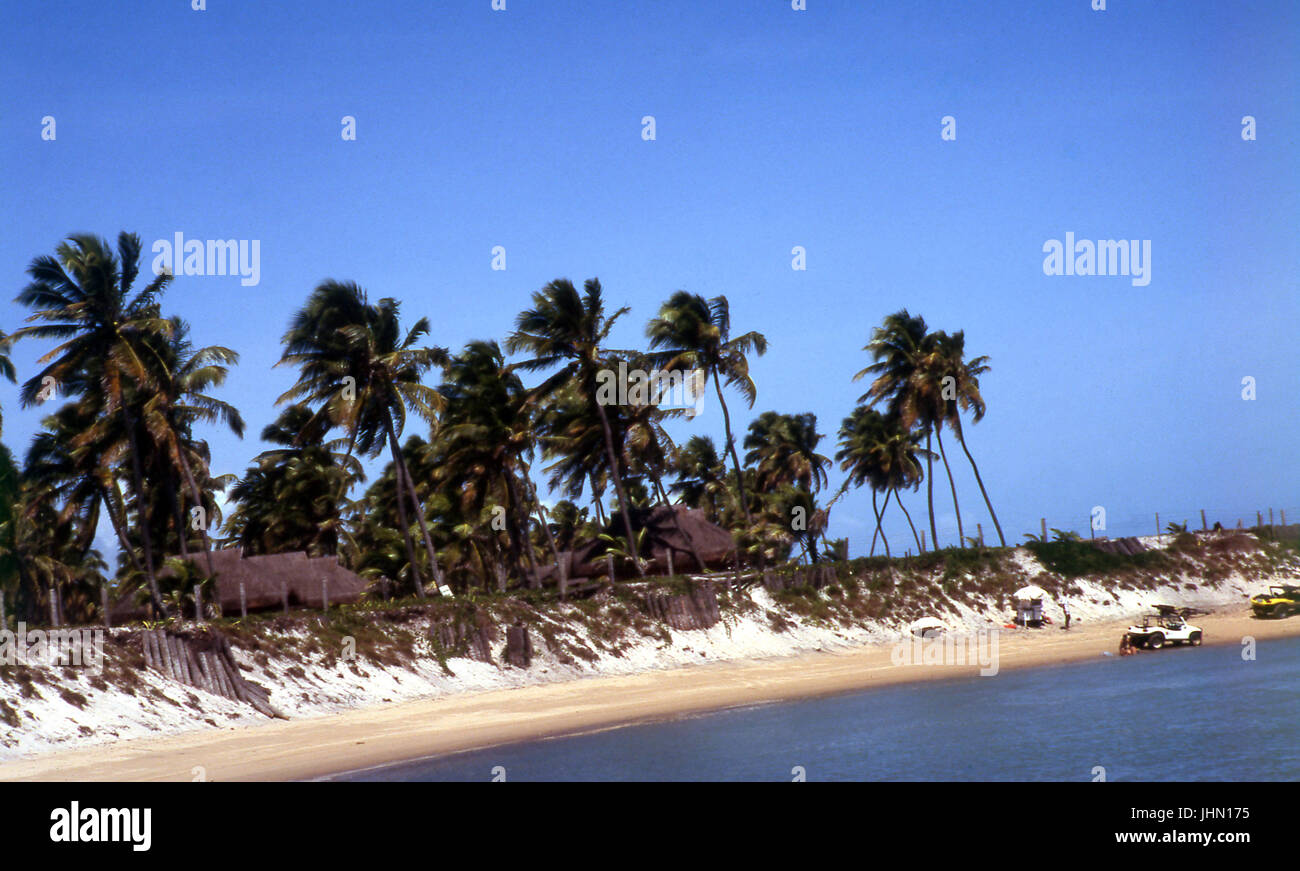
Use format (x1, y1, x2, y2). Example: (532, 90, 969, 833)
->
(0, 0, 1300, 553)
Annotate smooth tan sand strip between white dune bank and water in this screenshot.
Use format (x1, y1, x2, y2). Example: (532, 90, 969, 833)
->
(0, 606, 1300, 781)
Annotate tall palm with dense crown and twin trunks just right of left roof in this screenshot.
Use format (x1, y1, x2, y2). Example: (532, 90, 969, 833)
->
(277, 280, 447, 597)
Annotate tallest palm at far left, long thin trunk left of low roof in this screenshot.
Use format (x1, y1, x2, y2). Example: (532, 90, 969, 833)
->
(13, 233, 172, 615)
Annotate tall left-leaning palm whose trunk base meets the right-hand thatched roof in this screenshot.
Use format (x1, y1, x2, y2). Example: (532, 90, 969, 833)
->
(506, 278, 645, 577)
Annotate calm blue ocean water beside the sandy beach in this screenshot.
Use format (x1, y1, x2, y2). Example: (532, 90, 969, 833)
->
(334, 638, 1300, 781)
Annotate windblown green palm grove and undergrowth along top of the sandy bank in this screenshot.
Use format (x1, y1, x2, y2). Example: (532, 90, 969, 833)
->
(0, 233, 1248, 634)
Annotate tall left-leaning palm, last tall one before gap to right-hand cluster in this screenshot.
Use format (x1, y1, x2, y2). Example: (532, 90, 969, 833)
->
(646, 290, 767, 525)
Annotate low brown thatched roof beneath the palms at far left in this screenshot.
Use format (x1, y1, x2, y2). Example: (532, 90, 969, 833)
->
(112, 549, 367, 621)
